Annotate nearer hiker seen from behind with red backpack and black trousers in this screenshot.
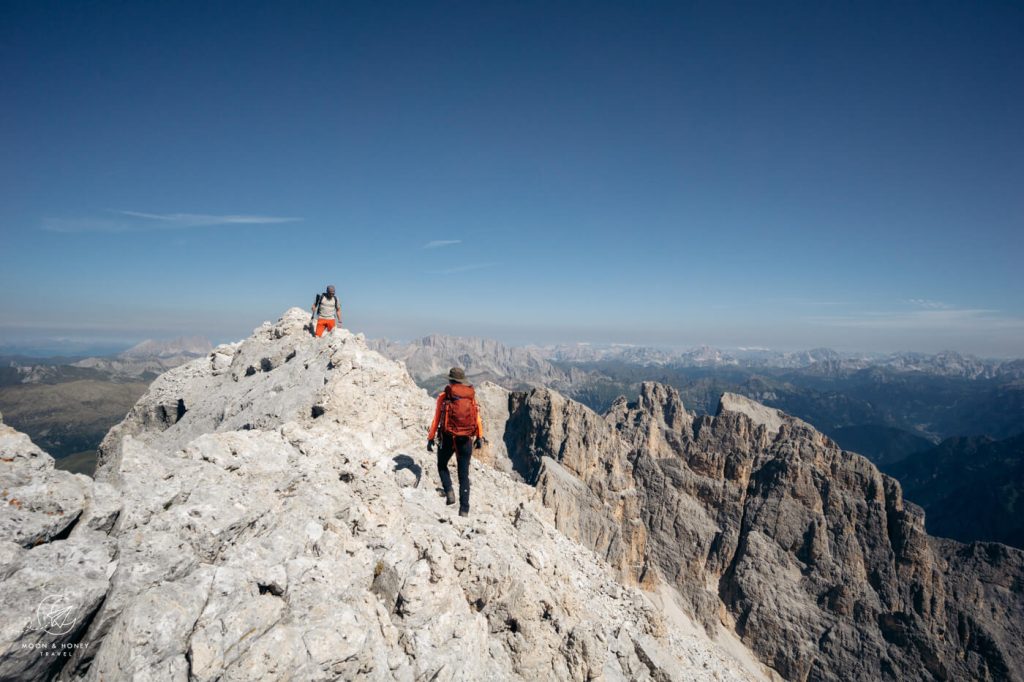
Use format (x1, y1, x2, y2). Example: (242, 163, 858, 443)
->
(427, 367, 486, 516)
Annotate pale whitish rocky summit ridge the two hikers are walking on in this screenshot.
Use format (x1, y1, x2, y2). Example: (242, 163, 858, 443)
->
(0, 308, 761, 681)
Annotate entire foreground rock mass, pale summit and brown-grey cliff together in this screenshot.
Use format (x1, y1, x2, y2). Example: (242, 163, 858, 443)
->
(0, 315, 1024, 681)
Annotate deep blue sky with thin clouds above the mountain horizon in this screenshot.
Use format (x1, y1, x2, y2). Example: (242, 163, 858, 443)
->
(0, 0, 1024, 356)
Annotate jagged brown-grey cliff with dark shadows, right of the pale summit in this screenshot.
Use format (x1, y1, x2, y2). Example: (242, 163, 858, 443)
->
(485, 384, 1024, 680)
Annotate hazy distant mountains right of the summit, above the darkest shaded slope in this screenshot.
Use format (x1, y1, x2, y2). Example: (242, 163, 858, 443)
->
(373, 335, 1024, 438)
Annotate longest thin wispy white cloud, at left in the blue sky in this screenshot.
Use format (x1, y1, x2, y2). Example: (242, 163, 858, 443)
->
(41, 211, 302, 233)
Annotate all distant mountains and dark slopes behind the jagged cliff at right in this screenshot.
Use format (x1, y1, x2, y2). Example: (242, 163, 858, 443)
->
(372, 335, 1024, 547)
